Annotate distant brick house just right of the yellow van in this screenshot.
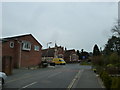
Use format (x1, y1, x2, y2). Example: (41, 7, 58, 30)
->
(64, 49, 79, 63)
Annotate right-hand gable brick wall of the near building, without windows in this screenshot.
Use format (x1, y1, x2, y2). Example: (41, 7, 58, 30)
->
(19, 36, 41, 67)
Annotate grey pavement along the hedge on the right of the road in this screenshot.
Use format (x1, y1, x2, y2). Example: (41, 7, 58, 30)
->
(74, 69, 104, 88)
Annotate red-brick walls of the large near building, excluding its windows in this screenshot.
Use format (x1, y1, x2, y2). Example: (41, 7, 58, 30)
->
(2, 35, 42, 67)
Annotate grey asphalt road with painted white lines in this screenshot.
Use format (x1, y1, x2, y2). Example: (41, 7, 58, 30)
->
(3, 64, 103, 90)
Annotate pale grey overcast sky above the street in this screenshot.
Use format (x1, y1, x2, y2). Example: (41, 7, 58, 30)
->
(2, 2, 118, 51)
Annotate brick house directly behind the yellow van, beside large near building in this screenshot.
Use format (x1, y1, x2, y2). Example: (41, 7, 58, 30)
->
(42, 44, 64, 61)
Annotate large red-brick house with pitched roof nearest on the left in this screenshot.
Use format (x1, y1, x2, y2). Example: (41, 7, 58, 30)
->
(0, 34, 42, 68)
